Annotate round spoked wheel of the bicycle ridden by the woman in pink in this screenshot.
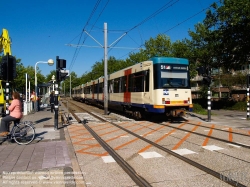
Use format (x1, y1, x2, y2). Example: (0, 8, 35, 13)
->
(13, 123, 35, 145)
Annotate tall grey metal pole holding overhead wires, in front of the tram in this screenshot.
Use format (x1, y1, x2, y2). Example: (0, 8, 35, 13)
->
(104, 23, 108, 115)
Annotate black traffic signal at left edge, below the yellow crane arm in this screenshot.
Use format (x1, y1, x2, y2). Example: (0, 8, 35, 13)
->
(0, 55, 16, 81)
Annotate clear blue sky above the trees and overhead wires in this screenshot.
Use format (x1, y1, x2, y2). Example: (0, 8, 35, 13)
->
(0, 0, 215, 76)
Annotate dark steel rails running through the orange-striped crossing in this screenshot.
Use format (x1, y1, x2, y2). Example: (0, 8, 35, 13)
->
(62, 98, 249, 187)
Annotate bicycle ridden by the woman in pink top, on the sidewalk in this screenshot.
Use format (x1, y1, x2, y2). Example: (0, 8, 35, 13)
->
(1, 119, 35, 145)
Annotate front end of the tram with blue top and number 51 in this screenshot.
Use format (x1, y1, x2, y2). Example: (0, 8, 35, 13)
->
(152, 57, 193, 117)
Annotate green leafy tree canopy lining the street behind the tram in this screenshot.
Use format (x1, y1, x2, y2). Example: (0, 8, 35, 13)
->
(1, 0, 250, 95)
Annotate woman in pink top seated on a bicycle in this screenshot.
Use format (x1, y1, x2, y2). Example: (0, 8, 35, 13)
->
(0, 92, 23, 136)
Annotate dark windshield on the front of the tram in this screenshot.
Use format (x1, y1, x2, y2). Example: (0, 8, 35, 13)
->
(154, 64, 190, 89)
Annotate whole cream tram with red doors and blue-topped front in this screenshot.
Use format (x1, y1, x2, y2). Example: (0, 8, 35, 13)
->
(73, 57, 193, 119)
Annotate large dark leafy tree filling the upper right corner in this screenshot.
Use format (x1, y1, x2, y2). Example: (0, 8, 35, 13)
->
(189, 0, 250, 69)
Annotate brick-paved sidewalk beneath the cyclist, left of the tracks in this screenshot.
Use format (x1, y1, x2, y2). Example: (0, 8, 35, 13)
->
(0, 106, 85, 187)
